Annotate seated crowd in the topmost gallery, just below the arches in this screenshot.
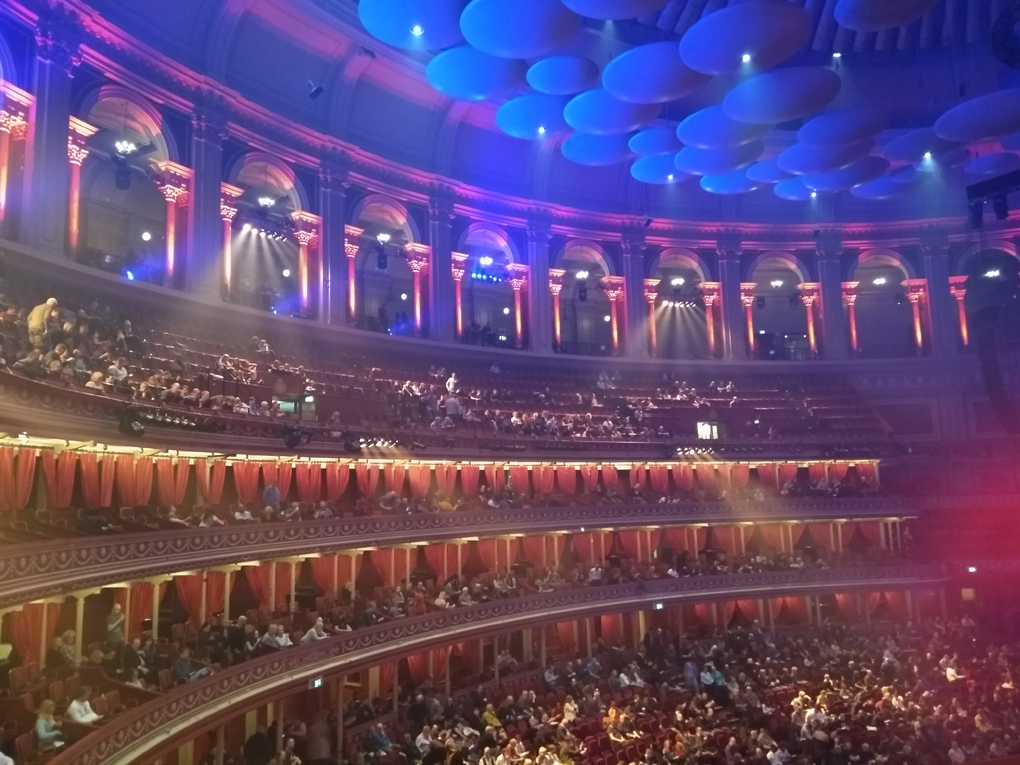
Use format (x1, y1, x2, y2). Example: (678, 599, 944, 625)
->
(0, 279, 889, 448)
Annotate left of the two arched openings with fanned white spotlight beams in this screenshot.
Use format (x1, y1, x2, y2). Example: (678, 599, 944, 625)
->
(231, 153, 306, 314)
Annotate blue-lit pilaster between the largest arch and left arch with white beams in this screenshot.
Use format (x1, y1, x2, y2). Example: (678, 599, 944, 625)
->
(187, 109, 230, 296)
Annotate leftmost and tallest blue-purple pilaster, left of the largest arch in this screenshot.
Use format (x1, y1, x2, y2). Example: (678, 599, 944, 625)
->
(22, 12, 82, 254)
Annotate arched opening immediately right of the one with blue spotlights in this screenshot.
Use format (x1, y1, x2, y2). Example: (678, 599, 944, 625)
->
(557, 241, 613, 356)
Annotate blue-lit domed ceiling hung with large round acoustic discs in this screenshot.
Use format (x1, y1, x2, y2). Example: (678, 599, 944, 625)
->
(81, 0, 1020, 221)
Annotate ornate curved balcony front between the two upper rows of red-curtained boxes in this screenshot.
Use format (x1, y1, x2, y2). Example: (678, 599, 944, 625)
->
(0, 498, 917, 608)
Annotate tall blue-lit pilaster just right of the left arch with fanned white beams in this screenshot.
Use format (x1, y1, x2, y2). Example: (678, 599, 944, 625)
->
(318, 154, 353, 324)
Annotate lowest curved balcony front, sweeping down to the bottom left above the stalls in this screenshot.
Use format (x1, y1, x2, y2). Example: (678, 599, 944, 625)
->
(51, 566, 949, 765)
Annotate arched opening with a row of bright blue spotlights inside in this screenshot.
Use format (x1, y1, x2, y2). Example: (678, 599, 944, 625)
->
(457, 223, 516, 348)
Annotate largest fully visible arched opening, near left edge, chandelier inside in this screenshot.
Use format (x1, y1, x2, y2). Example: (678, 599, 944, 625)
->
(78, 91, 170, 284)
